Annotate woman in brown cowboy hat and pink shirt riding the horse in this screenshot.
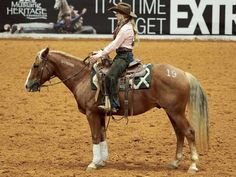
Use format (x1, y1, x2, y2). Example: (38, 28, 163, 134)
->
(91, 2, 138, 113)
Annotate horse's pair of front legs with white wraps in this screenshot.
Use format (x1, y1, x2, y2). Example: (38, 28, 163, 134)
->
(86, 111, 108, 171)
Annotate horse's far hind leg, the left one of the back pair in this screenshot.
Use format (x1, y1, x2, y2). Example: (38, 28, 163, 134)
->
(167, 113, 184, 169)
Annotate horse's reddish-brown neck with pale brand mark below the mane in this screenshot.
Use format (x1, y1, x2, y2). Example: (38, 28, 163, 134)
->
(50, 53, 90, 92)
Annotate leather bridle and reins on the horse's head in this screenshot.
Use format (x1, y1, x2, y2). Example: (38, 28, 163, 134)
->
(33, 55, 90, 91)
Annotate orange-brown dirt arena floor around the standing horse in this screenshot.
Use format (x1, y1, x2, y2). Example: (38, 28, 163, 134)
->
(0, 40, 236, 177)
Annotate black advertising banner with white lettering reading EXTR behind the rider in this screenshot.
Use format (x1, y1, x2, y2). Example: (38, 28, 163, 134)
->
(0, 0, 236, 35)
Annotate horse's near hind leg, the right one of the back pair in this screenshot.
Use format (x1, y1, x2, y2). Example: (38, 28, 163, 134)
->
(170, 113, 198, 173)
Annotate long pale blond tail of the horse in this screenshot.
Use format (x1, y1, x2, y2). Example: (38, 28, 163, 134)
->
(186, 73, 209, 151)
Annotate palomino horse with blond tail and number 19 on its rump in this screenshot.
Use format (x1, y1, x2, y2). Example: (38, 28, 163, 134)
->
(25, 48, 208, 172)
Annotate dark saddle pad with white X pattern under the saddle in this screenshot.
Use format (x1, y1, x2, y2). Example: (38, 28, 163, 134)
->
(90, 64, 152, 91)
